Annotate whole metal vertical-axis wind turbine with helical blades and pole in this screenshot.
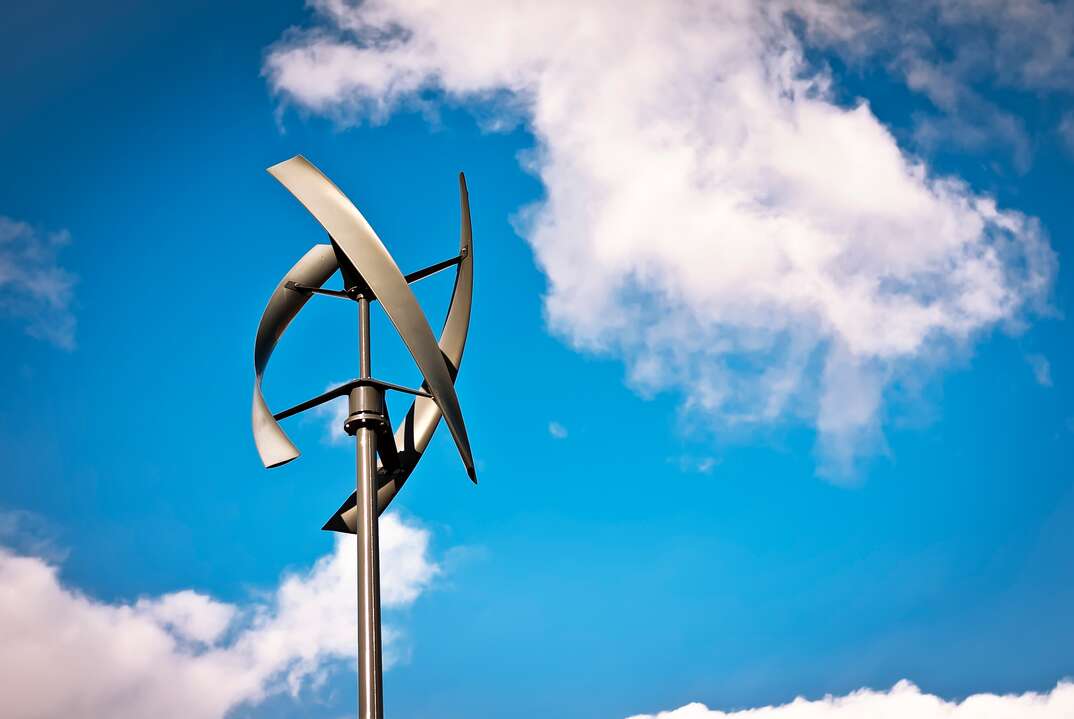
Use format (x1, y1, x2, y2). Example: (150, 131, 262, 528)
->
(252, 156, 477, 719)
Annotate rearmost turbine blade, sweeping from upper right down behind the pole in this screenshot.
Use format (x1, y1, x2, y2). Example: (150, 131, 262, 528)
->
(324, 173, 474, 533)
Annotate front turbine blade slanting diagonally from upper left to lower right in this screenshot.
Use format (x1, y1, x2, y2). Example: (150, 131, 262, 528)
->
(269, 155, 477, 479)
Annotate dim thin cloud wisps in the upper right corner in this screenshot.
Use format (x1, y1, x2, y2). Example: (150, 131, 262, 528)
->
(810, 0, 1074, 166)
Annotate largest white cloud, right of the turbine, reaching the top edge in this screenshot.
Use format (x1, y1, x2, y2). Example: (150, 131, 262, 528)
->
(264, 0, 1056, 476)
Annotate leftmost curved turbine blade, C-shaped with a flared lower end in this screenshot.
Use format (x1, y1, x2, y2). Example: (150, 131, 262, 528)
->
(252, 245, 339, 469)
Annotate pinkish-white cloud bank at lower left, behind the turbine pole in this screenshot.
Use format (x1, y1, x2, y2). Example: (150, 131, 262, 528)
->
(0, 515, 439, 719)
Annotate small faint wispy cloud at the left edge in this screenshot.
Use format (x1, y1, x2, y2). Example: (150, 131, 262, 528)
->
(0, 215, 75, 349)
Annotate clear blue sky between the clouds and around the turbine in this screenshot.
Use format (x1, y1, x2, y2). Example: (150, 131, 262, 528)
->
(0, 2, 1074, 719)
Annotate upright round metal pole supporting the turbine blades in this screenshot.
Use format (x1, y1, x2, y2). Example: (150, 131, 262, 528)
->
(348, 296, 384, 719)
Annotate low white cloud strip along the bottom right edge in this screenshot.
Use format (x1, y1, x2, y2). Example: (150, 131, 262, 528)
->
(630, 681, 1074, 719)
